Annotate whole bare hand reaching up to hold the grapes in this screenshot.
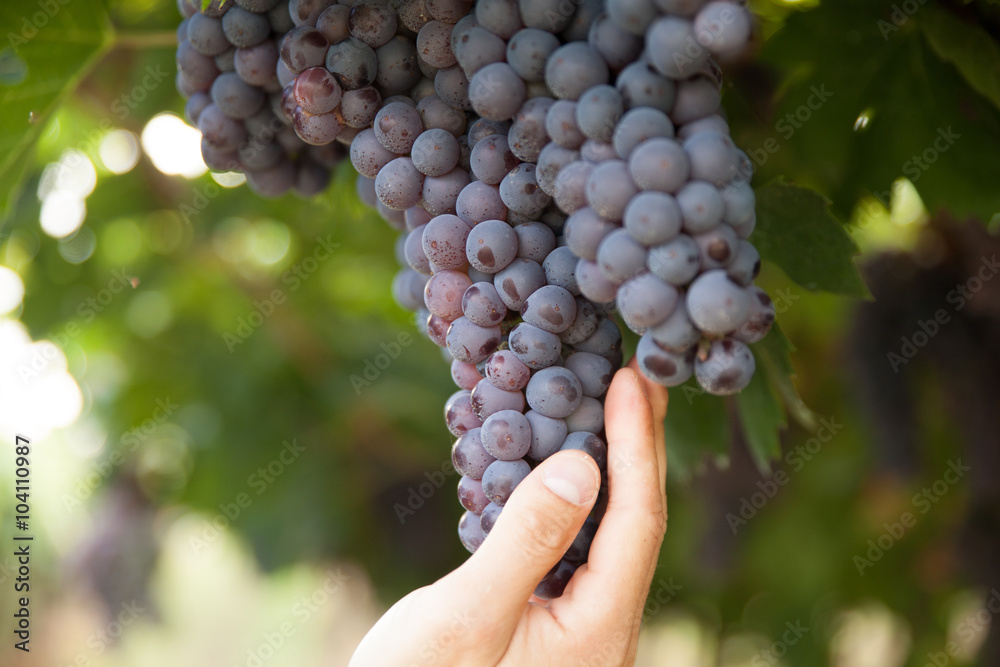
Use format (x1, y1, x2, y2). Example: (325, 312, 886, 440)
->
(350, 360, 667, 667)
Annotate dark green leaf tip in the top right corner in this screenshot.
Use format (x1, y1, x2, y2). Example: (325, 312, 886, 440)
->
(920, 6, 1000, 113)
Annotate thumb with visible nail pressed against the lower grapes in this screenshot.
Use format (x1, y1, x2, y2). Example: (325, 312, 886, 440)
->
(454, 451, 601, 622)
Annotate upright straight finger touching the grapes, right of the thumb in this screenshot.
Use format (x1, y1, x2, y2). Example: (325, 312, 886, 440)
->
(556, 368, 666, 623)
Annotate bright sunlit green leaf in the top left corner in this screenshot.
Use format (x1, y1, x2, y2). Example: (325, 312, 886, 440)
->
(0, 0, 114, 218)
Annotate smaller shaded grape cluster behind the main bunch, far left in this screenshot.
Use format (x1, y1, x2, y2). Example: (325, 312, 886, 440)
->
(177, 0, 347, 197)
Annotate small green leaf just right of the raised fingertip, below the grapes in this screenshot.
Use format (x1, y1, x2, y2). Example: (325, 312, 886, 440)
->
(663, 382, 732, 477)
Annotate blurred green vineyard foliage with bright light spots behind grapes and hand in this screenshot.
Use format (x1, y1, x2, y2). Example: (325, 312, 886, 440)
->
(0, 0, 1000, 667)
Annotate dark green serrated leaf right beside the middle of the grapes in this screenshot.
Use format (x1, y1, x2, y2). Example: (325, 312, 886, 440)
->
(753, 179, 869, 297)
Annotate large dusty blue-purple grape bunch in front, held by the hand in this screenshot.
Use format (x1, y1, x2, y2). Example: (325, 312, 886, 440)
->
(181, 0, 774, 598)
